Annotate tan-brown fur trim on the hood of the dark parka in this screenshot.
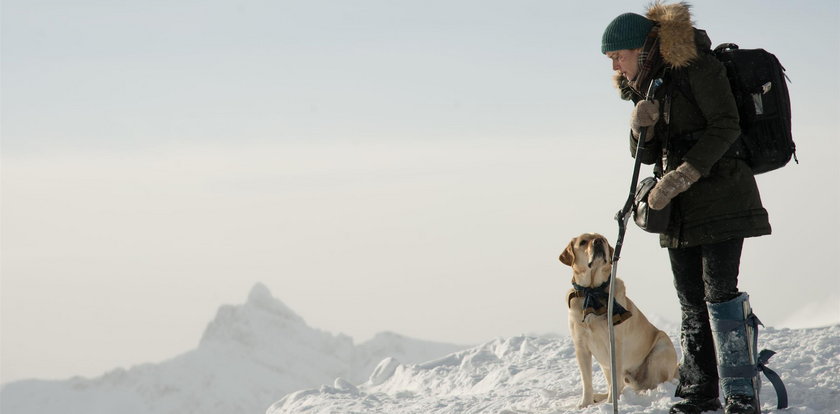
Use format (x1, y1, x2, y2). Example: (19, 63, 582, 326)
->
(613, 0, 712, 100)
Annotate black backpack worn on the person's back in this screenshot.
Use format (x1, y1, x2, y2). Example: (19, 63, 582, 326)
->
(712, 43, 799, 174)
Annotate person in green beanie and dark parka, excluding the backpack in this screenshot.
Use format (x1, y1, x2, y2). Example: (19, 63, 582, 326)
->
(601, 2, 770, 413)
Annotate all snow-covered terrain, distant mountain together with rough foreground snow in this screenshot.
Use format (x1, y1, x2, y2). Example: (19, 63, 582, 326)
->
(0, 284, 840, 414)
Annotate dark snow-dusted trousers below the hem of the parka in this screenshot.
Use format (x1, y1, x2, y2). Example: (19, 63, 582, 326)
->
(668, 238, 744, 399)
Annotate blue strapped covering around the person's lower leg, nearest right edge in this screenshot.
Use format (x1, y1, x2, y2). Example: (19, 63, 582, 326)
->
(706, 292, 761, 414)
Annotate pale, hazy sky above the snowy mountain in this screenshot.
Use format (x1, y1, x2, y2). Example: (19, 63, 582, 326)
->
(0, 0, 840, 383)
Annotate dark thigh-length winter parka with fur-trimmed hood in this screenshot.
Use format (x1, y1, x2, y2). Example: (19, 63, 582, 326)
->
(616, 3, 770, 248)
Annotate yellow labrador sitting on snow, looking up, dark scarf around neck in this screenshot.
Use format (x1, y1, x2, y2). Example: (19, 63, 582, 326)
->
(560, 233, 677, 408)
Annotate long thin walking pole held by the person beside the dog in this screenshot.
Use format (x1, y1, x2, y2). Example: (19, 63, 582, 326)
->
(607, 79, 662, 414)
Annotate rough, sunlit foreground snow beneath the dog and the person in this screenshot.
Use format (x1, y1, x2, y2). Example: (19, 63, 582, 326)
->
(268, 325, 840, 414)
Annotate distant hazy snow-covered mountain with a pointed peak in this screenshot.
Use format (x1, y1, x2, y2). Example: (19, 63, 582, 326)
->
(0, 284, 463, 414)
